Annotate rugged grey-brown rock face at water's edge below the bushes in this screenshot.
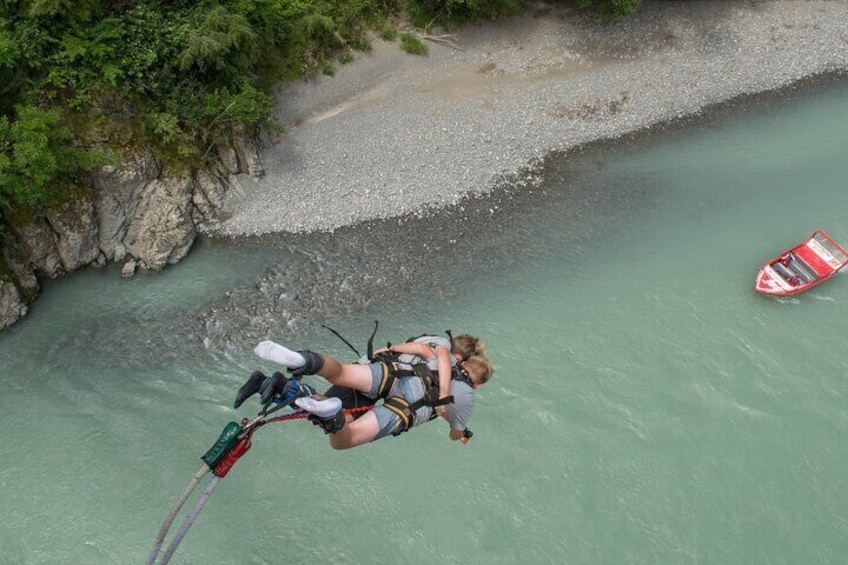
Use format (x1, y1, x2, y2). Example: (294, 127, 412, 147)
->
(0, 138, 262, 329)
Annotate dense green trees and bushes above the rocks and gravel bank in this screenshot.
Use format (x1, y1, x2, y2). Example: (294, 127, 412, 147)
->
(0, 0, 635, 213)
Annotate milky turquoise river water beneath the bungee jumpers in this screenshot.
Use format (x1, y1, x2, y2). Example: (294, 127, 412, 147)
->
(0, 76, 848, 565)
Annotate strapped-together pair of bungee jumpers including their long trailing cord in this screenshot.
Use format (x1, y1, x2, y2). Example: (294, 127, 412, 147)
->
(146, 324, 493, 565)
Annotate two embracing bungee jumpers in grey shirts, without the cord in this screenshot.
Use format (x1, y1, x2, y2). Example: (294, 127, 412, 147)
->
(235, 334, 493, 449)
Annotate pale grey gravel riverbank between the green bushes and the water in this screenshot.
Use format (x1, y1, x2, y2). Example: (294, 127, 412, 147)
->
(219, 0, 848, 236)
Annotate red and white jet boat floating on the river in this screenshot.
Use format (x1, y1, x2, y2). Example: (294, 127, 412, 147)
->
(754, 230, 848, 296)
